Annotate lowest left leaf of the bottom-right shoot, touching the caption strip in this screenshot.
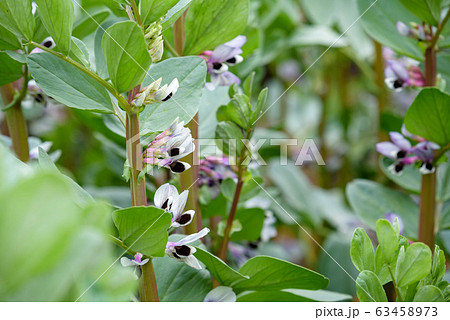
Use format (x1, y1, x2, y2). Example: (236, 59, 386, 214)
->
(356, 270, 387, 302)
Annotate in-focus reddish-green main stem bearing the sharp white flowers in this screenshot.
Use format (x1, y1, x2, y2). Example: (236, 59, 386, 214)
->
(126, 86, 159, 302)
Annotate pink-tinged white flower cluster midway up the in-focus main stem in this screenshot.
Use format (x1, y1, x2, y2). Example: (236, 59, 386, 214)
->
(143, 118, 195, 173)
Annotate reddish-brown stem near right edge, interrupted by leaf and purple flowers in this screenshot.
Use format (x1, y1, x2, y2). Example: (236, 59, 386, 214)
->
(418, 33, 439, 251)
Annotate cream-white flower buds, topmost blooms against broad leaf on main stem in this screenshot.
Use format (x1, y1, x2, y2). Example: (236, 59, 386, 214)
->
(132, 78, 180, 107)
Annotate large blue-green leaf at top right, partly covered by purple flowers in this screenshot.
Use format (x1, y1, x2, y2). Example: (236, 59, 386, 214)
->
(358, 0, 424, 60)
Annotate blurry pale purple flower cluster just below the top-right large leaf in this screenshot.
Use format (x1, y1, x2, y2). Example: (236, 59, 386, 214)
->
(383, 48, 425, 91)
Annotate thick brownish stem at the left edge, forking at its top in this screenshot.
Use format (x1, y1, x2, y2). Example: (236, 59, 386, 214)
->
(1, 80, 30, 162)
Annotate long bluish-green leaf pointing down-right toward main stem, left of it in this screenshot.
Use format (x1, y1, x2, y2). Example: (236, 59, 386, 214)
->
(28, 53, 113, 113)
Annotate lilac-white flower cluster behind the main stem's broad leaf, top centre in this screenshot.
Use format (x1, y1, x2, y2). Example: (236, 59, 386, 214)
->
(200, 36, 247, 90)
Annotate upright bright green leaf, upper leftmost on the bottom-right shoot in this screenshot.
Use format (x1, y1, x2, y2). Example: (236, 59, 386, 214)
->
(350, 228, 375, 271)
